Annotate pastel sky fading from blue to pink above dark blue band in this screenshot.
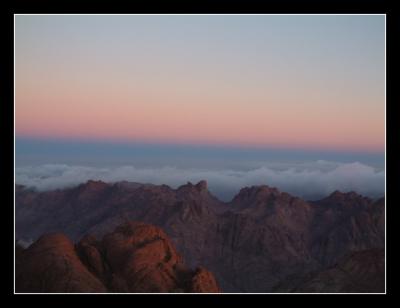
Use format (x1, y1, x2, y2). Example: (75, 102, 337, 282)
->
(15, 15, 385, 153)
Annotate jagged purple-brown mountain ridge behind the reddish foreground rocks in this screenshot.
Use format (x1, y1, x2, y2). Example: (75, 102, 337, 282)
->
(16, 181, 385, 292)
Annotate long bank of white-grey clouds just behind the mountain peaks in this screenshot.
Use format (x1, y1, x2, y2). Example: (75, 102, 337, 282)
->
(16, 160, 385, 201)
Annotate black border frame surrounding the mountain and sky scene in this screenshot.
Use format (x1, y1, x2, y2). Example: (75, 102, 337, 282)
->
(0, 0, 400, 304)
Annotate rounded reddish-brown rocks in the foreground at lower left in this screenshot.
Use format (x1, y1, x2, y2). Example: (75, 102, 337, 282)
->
(16, 222, 220, 293)
